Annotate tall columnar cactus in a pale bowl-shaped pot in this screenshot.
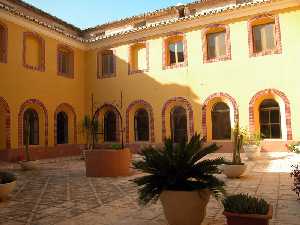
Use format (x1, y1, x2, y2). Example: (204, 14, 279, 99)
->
(222, 123, 247, 178)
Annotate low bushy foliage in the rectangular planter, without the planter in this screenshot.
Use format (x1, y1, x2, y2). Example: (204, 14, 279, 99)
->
(222, 194, 269, 215)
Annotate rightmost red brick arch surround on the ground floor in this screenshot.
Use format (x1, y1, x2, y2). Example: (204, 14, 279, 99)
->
(249, 89, 293, 140)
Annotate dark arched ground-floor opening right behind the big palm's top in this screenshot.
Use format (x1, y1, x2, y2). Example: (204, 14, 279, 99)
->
(171, 106, 188, 143)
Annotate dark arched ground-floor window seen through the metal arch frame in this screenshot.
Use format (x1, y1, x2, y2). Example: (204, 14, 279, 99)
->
(104, 111, 117, 142)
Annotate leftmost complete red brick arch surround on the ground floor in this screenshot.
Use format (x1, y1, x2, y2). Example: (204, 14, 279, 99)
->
(18, 99, 48, 148)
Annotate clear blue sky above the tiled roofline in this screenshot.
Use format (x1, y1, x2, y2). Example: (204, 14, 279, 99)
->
(25, 0, 193, 28)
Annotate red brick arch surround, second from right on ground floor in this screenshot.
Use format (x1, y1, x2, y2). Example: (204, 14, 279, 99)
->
(202, 92, 239, 136)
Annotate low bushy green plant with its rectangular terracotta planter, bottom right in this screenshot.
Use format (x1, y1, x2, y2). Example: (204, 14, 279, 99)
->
(222, 194, 273, 225)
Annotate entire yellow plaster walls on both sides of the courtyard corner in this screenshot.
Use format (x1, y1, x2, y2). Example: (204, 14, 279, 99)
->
(0, 6, 300, 148)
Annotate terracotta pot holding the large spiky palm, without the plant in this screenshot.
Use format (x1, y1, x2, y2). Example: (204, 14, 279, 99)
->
(160, 189, 211, 225)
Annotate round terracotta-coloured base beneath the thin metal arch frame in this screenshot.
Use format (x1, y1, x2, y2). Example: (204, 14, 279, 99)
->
(85, 148, 131, 177)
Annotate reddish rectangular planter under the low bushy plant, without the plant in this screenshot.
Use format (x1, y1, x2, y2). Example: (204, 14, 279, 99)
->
(223, 205, 273, 225)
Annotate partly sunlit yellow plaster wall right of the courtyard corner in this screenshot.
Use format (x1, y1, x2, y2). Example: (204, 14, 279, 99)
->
(86, 10, 300, 142)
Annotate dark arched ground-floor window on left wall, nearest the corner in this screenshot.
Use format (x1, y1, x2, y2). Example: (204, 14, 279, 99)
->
(56, 112, 68, 144)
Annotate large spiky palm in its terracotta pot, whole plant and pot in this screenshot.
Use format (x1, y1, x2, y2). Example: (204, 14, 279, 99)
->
(133, 134, 225, 225)
